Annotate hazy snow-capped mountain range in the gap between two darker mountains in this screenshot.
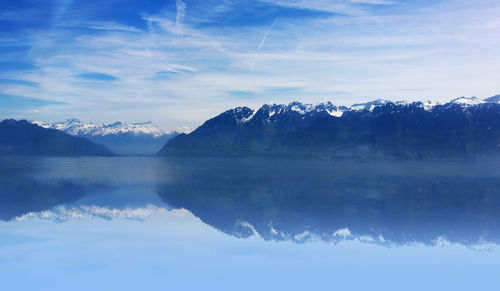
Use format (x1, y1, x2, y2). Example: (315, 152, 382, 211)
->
(33, 118, 179, 155)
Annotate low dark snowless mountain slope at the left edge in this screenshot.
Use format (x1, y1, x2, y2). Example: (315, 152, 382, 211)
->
(0, 119, 112, 156)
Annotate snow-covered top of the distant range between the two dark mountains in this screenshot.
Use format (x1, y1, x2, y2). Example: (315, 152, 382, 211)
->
(32, 118, 174, 138)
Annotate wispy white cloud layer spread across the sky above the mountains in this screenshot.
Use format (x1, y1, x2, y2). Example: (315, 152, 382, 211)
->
(6, 0, 500, 130)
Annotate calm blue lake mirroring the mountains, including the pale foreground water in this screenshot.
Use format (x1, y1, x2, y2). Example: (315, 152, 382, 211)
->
(0, 157, 500, 290)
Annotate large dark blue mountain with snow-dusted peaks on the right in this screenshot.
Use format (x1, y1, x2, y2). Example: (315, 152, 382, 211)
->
(158, 97, 500, 158)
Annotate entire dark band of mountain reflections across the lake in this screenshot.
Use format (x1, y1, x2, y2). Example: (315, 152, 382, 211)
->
(0, 157, 500, 245)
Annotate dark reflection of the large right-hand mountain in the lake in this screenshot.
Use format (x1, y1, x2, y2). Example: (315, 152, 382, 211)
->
(159, 159, 500, 245)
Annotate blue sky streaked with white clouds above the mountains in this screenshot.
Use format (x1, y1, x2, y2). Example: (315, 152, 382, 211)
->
(0, 0, 500, 129)
